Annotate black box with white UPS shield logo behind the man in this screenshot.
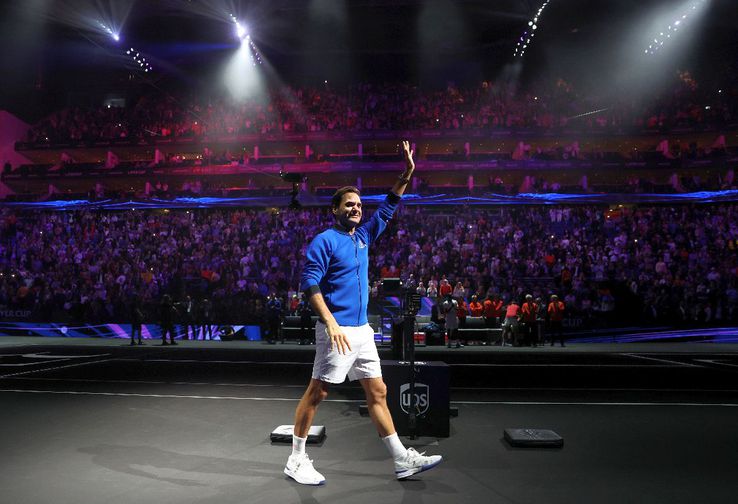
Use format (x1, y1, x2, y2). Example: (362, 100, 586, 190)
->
(382, 360, 450, 437)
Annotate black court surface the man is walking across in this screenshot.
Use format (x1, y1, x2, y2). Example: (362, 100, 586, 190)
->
(0, 337, 738, 504)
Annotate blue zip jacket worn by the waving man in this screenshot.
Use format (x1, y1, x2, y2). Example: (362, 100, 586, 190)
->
(300, 193, 400, 327)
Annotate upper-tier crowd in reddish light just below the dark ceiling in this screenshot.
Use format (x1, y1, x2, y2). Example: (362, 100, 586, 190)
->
(26, 74, 738, 144)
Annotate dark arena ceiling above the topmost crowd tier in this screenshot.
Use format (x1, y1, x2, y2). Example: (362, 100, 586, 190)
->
(0, 0, 738, 118)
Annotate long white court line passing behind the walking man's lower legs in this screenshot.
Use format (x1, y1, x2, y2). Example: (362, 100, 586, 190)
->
(0, 389, 738, 408)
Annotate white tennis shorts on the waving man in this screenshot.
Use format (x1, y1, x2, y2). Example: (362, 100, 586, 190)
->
(313, 321, 382, 383)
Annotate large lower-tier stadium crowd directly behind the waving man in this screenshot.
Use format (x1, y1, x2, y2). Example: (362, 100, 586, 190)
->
(0, 204, 738, 324)
